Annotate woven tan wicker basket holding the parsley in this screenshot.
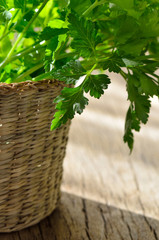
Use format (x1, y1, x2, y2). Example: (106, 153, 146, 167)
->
(0, 80, 70, 232)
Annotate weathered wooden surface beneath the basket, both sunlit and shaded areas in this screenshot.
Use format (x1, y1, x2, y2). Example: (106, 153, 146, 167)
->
(0, 75, 159, 240)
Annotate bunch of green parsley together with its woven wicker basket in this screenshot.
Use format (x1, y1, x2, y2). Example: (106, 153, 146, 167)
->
(0, 0, 159, 232)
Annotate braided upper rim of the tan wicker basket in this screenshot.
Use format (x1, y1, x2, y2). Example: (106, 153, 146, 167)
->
(0, 79, 65, 92)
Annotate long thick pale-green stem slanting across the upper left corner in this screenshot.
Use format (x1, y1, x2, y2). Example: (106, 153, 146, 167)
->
(0, 0, 48, 70)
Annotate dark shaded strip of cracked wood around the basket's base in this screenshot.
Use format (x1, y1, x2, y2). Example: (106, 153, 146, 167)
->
(0, 192, 159, 240)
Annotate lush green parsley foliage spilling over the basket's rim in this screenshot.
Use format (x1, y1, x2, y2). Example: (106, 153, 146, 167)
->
(0, 0, 159, 150)
